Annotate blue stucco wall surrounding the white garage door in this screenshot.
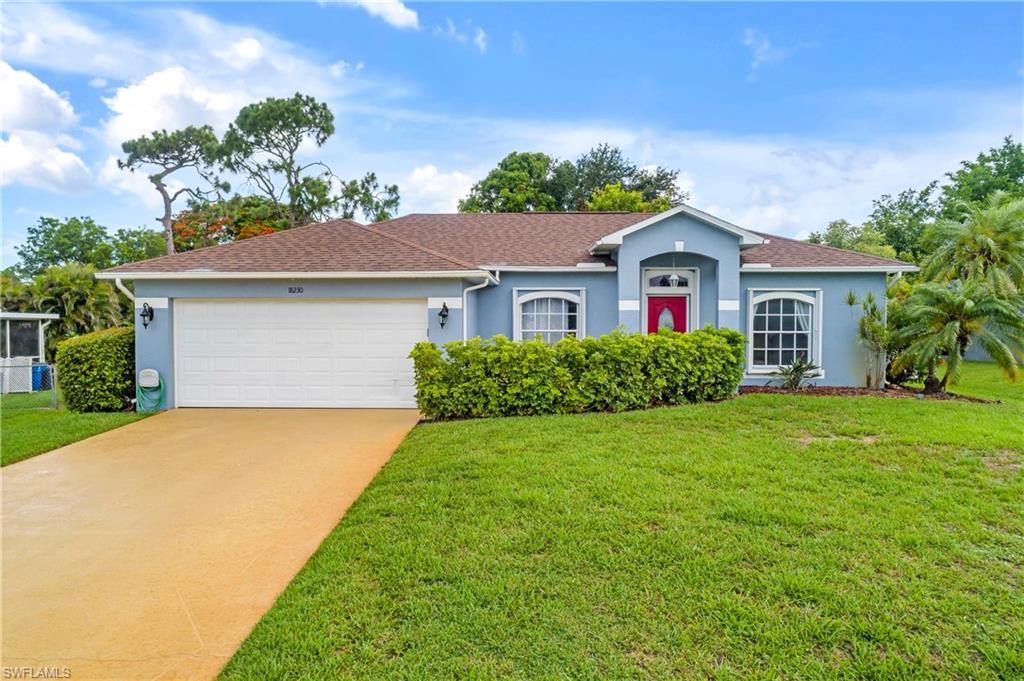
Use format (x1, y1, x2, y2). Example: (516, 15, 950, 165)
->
(135, 279, 473, 409)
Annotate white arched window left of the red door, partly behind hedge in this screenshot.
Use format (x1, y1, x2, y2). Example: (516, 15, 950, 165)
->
(512, 289, 587, 343)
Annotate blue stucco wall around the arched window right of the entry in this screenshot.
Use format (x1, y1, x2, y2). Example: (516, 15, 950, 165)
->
(739, 271, 886, 387)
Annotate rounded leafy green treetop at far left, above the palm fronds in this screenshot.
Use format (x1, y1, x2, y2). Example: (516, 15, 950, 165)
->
(15, 216, 114, 276)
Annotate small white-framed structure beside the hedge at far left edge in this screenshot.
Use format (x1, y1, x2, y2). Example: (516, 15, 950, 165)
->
(0, 312, 60, 394)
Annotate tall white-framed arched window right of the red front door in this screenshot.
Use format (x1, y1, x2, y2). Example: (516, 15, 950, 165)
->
(746, 290, 822, 374)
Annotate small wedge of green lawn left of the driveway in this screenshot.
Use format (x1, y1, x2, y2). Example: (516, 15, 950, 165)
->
(0, 393, 146, 466)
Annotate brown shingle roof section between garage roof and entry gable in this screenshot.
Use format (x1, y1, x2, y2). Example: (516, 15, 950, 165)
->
(374, 213, 651, 267)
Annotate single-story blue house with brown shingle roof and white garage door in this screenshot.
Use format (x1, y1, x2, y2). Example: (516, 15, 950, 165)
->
(99, 205, 914, 408)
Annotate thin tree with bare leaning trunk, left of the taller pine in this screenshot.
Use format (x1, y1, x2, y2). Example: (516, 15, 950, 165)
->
(118, 125, 227, 254)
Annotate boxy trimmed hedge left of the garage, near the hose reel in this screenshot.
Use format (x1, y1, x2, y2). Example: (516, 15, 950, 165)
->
(57, 327, 135, 412)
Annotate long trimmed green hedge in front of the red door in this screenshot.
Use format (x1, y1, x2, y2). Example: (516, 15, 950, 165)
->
(410, 327, 744, 419)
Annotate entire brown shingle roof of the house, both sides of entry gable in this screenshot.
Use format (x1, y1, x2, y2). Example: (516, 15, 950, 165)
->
(106, 213, 906, 274)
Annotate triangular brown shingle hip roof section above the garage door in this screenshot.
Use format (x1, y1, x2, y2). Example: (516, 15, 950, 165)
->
(106, 220, 476, 273)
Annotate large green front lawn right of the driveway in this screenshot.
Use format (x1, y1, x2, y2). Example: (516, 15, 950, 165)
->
(222, 364, 1024, 679)
